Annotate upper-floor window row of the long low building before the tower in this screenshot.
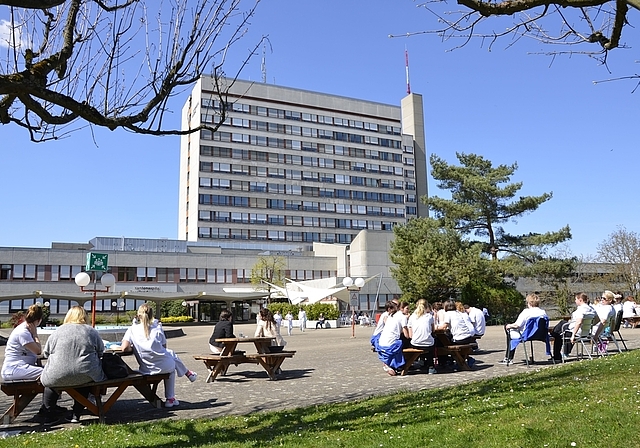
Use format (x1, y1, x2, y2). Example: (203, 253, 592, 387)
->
(0, 264, 336, 284)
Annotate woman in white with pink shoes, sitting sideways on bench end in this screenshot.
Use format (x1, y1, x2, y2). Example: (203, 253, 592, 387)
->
(122, 303, 198, 408)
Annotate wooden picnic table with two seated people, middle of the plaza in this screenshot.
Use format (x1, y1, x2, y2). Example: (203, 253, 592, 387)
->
(193, 337, 296, 383)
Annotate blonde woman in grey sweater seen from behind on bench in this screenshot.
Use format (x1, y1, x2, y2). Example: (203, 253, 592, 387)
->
(40, 306, 107, 424)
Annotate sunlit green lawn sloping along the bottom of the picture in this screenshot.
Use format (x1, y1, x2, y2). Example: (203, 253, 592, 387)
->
(5, 350, 640, 448)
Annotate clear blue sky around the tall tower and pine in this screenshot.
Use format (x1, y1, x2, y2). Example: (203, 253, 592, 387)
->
(0, 0, 640, 255)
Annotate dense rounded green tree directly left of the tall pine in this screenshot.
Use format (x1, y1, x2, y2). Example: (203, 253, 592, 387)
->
(389, 218, 499, 301)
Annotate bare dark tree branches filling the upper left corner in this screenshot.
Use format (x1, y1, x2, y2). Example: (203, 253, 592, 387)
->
(0, 0, 264, 141)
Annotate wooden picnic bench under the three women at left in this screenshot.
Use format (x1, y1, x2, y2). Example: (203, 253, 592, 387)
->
(0, 373, 169, 425)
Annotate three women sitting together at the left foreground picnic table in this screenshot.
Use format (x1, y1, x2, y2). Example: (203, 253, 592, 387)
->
(0, 304, 198, 425)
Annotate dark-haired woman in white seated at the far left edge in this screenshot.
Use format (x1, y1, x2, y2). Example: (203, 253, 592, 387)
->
(2, 305, 42, 382)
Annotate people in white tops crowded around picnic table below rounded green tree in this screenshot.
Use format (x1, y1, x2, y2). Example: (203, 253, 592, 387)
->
(371, 299, 486, 376)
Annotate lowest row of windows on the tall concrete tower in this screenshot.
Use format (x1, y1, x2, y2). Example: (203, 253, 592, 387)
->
(198, 229, 396, 244)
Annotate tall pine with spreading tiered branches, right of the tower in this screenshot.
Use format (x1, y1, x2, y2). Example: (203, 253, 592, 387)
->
(422, 153, 571, 275)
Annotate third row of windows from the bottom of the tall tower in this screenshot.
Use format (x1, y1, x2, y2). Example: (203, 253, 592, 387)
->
(198, 194, 404, 208)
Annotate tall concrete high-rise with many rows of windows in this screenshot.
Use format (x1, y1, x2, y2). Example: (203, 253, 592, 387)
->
(178, 77, 427, 250)
